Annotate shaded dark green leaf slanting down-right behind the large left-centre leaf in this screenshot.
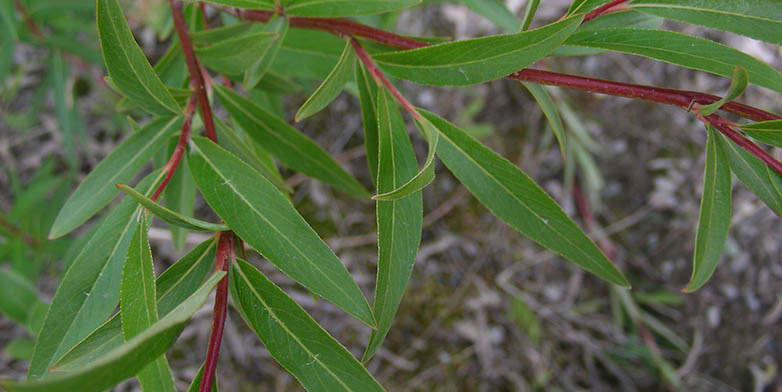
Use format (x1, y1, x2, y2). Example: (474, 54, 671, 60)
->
(215, 86, 369, 198)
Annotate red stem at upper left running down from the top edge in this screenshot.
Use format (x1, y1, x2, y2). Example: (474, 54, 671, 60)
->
(168, 0, 217, 143)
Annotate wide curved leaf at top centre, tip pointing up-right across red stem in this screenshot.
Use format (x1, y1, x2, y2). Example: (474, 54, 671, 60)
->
(373, 16, 583, 86)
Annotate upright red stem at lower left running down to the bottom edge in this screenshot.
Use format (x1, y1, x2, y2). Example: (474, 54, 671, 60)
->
(199, 231, 234, 392)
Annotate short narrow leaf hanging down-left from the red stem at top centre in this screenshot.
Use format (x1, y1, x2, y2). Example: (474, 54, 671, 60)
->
(295, 41, 356, 122)
